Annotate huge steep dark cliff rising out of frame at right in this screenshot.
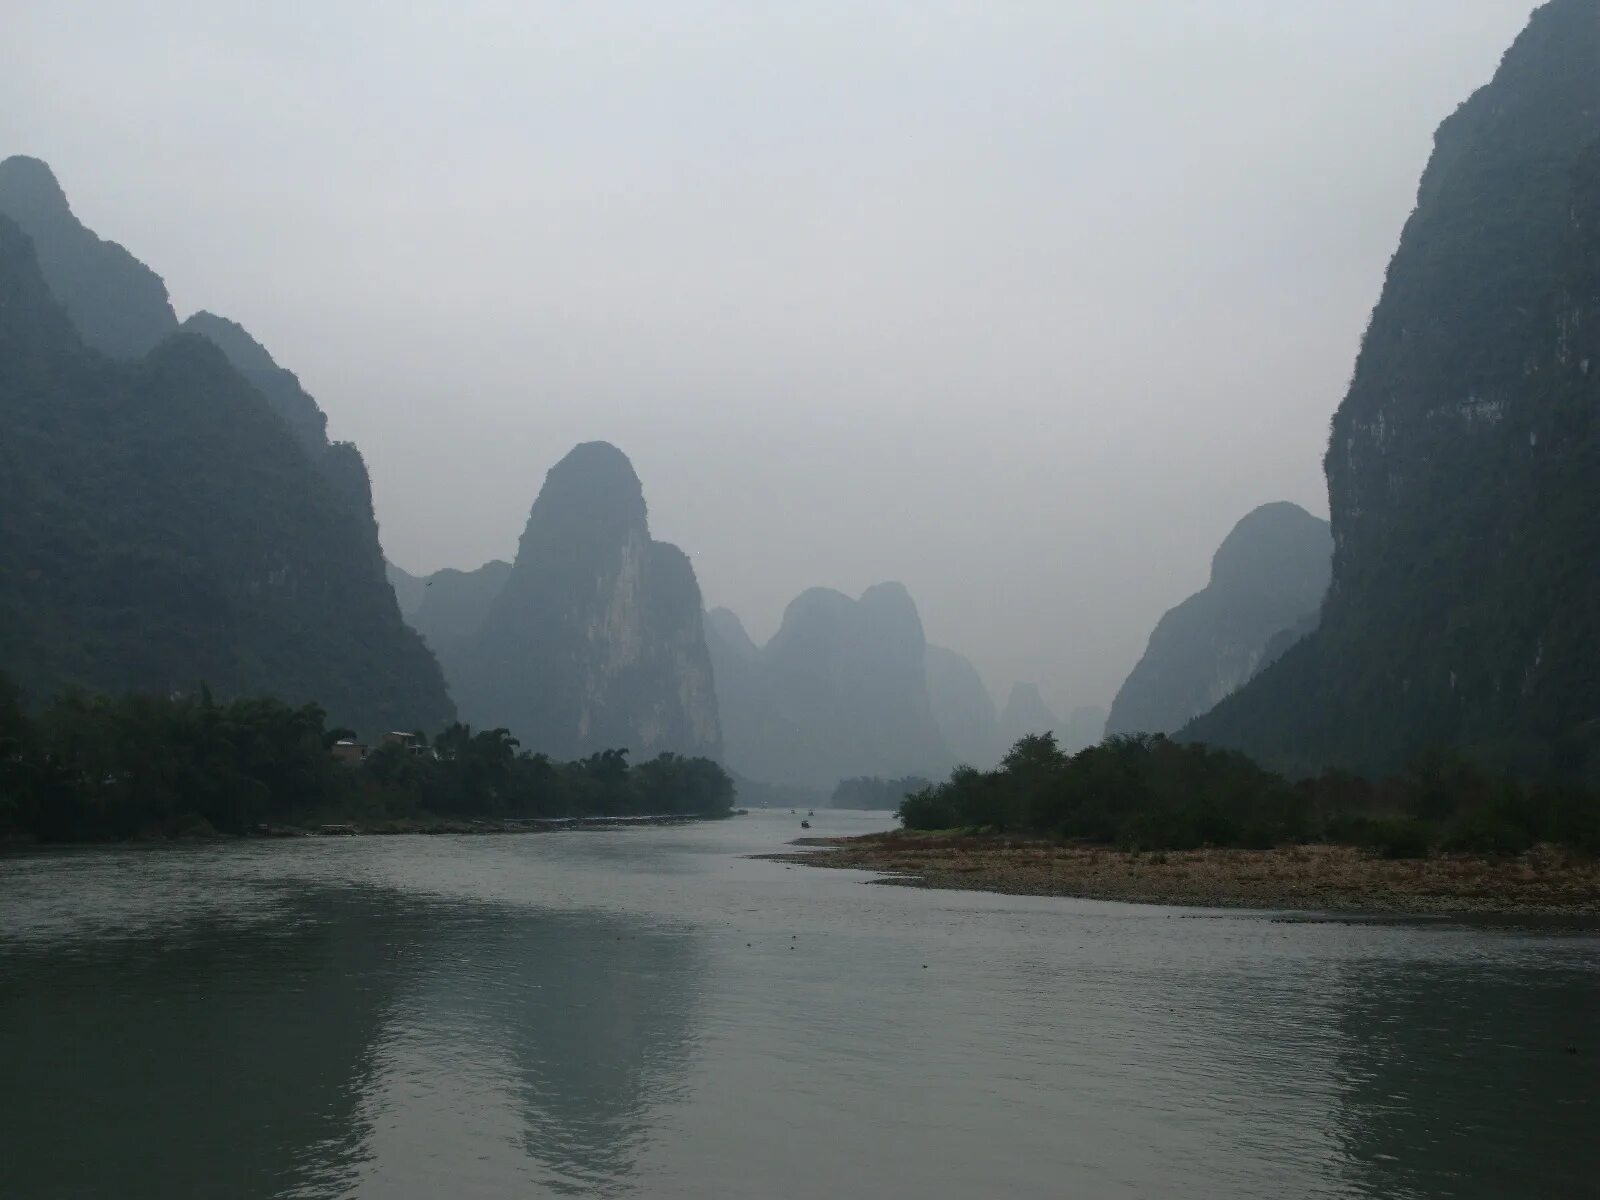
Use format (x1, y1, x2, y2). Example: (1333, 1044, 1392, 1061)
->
(1186, 0, 1600, 778)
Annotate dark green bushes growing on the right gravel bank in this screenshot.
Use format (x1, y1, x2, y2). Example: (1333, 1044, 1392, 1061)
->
(899, 734, 1600, 858)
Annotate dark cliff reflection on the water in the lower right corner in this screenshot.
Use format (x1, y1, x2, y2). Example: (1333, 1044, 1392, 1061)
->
(1338, 957, 1600, 1200)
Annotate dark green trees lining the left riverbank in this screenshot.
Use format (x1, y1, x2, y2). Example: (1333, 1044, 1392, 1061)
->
(0, 675, 734, 842)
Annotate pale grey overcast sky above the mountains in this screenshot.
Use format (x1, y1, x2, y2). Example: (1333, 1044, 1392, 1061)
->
(0, 0, 1533, 709)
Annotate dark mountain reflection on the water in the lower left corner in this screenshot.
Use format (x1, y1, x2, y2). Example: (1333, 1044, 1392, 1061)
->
(0, 893, 400, 1197)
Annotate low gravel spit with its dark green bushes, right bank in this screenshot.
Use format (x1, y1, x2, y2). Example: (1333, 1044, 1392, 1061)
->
(764, 734, 1600, 912)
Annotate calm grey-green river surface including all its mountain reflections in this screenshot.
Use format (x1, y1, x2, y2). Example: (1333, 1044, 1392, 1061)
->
(0, 813, 1600, 1200)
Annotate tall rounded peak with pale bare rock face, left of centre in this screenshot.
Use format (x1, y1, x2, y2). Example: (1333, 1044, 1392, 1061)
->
(446, 442, 722, 758)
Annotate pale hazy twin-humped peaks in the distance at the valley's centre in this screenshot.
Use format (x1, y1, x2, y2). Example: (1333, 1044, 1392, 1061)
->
(707, 584, 952, 790)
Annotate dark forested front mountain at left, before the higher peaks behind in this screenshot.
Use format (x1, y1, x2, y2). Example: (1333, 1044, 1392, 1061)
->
(0, 200, 453, 733)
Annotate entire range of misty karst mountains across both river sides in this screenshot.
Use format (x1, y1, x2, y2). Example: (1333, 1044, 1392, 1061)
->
(0, 0, 1600, 803)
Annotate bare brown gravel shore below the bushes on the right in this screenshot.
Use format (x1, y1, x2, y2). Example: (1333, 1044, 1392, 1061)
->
(760, 830, 1600, 915)
